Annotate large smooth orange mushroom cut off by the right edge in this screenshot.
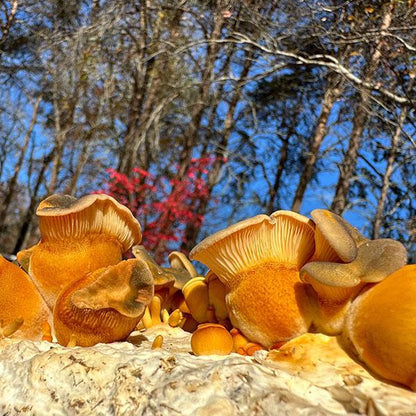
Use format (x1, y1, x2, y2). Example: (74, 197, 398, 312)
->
(342, 264, 416, 391)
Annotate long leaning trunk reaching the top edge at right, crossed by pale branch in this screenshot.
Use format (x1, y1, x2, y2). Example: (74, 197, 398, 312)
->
(331, 1, 394, 215)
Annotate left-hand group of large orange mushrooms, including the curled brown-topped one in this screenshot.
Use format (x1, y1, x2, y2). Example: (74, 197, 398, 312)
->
(0, 195, 153, 346)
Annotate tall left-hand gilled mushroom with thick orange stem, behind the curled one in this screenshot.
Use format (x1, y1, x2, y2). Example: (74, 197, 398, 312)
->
(18, 194, 141, 309)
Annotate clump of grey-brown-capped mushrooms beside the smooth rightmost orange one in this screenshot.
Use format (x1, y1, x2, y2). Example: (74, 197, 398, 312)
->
(300, 210, 406, 335)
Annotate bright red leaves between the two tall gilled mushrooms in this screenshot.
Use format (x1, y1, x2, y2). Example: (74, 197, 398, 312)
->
(99, 156, 224, 261)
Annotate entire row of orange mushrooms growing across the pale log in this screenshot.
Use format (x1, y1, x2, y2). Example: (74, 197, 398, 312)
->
(0, 195, 416, 390)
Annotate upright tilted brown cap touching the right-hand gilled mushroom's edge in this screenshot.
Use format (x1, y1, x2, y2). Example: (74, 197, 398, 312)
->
(311, 209, 357, 263)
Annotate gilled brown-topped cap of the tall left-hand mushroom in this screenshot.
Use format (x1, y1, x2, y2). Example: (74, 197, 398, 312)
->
(36, 194, 142, 251)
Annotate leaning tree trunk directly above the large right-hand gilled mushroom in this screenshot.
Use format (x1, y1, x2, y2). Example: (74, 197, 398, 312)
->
(291, 74, 342, 212)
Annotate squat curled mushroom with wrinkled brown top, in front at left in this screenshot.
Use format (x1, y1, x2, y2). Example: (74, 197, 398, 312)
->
(53, 259, 153, 346)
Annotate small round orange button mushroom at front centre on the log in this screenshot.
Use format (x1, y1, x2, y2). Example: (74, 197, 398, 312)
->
(191, 323, 233, 355)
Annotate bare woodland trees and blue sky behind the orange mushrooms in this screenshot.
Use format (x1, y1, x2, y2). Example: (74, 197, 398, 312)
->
(0, 0, 416, 256)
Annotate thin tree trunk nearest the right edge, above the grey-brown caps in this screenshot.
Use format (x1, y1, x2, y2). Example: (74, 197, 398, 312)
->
(372, 74, 415, 239)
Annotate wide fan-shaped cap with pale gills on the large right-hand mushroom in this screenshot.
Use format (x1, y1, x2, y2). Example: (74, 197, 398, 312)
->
(189, 211, 314, 281)
